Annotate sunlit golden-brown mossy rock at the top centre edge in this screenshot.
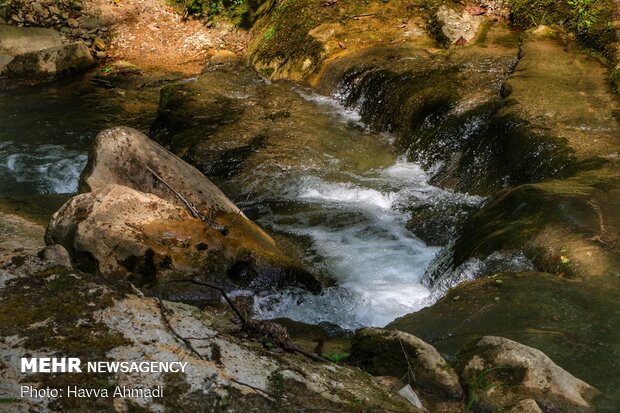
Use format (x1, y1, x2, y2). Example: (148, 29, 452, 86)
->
(248, 0, 434, 83)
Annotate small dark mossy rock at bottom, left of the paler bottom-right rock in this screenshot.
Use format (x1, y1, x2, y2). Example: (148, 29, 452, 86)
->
(351, 328, 464, 399)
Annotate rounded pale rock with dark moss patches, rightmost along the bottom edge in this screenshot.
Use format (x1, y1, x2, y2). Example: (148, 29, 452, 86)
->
(457, 336, 598, 413)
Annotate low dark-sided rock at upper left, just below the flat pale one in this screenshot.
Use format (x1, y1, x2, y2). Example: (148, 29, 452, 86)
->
(4, 43, 95, 79)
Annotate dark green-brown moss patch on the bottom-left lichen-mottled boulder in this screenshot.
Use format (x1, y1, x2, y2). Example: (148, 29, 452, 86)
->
(0, 267, 131, 412)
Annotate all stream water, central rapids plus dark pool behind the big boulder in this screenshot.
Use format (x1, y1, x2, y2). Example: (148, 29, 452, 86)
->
(0, 74, 481, 329)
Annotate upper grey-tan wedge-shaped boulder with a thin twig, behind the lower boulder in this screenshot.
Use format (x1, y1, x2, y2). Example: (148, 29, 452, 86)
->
(80, 127, 282, 255)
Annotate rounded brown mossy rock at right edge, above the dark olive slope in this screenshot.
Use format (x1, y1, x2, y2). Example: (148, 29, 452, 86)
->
(452, 163, 620, 277)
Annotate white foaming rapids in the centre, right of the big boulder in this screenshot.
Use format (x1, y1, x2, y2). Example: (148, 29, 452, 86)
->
(249, 161, 480, 329)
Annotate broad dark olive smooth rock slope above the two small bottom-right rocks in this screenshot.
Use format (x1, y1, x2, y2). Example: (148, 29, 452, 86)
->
(386, 273, 620, 413)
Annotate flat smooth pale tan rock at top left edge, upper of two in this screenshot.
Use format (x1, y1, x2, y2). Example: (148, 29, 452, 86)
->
(0, 25, 62, 56)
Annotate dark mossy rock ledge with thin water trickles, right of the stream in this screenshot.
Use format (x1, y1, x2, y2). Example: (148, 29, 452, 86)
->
(342, 58, 572, 195)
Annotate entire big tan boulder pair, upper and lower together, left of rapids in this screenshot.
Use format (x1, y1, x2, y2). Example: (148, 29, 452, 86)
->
(46, 127, 321, 292)
